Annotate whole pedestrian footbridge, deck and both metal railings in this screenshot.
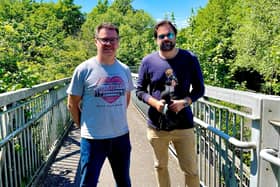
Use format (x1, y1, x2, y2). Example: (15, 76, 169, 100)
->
(0, 74, 280, 187)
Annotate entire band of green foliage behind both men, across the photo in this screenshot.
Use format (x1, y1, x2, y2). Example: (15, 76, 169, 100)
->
(0, 0, 280, 95)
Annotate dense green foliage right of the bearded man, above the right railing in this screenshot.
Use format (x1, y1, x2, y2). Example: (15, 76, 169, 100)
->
(179, 0, 280, 95)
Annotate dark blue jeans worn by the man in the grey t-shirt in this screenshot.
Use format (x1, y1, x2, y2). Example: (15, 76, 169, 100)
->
(80, 133, 131, 187)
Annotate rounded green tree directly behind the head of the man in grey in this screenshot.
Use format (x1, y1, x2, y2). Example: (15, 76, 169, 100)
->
(81, 0, 156, 66)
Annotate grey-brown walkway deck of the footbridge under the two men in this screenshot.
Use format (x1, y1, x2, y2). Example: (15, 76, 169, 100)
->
(39, 103, 184, 187)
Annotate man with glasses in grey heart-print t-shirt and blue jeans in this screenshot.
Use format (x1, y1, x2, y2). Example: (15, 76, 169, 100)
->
(67, 23, 133, 187)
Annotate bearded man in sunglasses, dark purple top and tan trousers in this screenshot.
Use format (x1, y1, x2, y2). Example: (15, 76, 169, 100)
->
(136, 20, 205, 187)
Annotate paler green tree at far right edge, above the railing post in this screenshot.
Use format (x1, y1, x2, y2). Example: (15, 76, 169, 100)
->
(233, 0, 280, 94)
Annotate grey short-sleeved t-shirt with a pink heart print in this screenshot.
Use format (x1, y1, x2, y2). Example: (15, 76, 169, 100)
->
(67, 57, 133, 139)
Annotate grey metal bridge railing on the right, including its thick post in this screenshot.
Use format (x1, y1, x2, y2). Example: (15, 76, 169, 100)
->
(132, 74, 280, 187)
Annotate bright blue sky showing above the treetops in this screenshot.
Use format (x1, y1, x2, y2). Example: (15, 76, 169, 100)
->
(74, 0, 208, 28)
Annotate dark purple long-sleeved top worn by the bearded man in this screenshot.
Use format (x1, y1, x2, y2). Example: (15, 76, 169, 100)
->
(136, 49, 205, 129)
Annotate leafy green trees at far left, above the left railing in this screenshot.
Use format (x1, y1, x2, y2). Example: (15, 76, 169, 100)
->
(0, 0, 84, 92)
